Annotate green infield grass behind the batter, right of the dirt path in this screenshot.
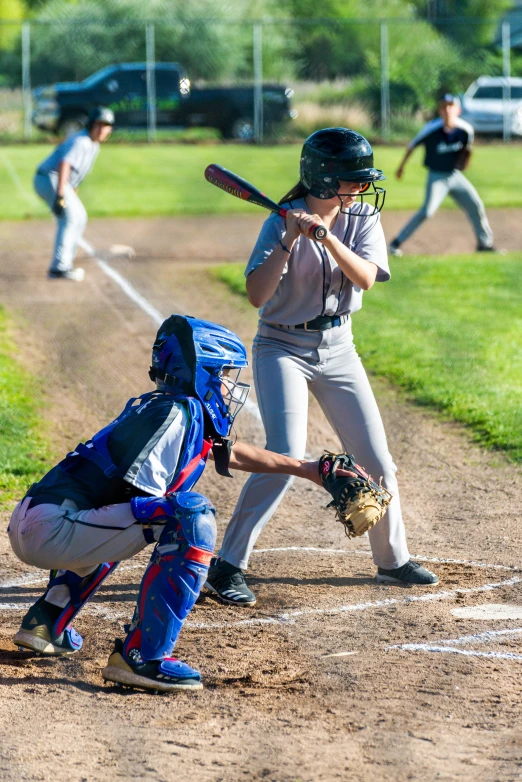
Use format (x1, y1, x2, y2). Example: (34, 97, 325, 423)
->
(210, 253, 522, 462)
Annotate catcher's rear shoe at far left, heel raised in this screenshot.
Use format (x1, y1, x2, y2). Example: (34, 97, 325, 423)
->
(13, 597, 83, 657)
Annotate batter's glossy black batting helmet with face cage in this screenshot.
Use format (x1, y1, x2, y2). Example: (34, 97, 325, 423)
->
(300, 128, 386, 216)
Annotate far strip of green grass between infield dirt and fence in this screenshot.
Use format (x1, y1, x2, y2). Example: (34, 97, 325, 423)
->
(0, 142, 522, 220)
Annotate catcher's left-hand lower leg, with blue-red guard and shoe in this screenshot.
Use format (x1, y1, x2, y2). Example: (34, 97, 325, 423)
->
(13, 562, 118, 656)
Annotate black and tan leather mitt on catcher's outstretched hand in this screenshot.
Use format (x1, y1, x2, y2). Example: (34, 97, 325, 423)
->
(319, 452, 392, 538)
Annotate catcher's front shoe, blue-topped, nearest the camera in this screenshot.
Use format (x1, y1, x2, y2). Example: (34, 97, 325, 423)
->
(102, 638, 203, 692)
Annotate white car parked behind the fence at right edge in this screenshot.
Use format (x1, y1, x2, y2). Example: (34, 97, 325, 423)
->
(462, 76, 522, 136)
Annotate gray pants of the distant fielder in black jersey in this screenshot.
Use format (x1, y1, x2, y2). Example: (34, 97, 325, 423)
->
(395, 170, 493, 247)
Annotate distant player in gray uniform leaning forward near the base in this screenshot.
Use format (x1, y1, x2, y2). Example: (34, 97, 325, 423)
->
(34, 107, 114, 282)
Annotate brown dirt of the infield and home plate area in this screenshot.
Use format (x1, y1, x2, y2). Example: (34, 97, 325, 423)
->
(0, 212, 522, 782)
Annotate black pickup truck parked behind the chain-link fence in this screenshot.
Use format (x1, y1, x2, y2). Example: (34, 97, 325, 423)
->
(33, 63, 295, 141)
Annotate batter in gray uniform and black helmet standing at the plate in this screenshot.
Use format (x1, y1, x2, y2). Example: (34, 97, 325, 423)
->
(207, 128, 438, 606)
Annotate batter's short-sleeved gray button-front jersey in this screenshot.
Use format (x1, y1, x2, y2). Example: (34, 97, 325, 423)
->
(245, 199, 390, 326)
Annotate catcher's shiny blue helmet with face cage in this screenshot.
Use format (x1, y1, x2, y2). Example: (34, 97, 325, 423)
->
(149, 315, 250, 437)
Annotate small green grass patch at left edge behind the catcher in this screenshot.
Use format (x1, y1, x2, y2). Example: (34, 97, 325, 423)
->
(0, 308, 51, 507)
